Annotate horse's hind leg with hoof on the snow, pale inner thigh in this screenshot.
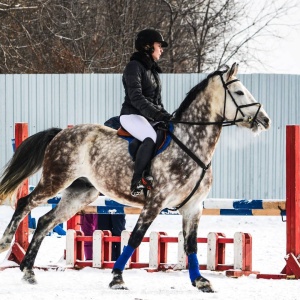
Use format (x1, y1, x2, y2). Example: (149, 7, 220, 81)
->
(20, 179, 99, 284)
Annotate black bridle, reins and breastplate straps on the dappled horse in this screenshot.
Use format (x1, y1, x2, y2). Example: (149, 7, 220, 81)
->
(166, 71, 261, 211)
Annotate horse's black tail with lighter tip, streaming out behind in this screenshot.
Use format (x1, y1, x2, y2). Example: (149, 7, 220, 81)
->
(0, 128, 62, 204)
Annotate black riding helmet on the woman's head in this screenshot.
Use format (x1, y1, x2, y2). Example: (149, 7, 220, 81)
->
(135, 29, 168, 51)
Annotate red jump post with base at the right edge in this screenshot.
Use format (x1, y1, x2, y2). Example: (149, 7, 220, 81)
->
(257, 125, 300, 279)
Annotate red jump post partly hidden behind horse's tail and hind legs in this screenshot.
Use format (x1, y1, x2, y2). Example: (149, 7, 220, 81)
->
(8, 123, 29, 264)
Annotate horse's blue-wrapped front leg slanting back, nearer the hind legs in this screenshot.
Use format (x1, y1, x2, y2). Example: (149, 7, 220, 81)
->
(109, 203, 161, 290)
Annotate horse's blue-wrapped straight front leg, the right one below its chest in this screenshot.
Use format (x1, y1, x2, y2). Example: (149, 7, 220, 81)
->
(182, 207, 214, 293)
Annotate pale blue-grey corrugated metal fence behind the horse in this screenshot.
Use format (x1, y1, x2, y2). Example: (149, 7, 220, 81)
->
(0, 74, 300, 199)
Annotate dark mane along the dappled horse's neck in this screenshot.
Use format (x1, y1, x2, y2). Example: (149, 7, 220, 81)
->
(174, 66, 227, 120)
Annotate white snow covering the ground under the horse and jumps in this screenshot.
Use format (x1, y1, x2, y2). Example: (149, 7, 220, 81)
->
(0, 206, 300, 300)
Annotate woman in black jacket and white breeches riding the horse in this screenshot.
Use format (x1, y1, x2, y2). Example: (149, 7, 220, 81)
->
(120, 29, 171, 197)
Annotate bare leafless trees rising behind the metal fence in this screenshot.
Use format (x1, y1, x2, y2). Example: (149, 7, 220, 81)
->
(0, 0, 298, 73)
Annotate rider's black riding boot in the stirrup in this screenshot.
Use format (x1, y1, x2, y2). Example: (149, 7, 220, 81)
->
(131, 138, 155, 197)
